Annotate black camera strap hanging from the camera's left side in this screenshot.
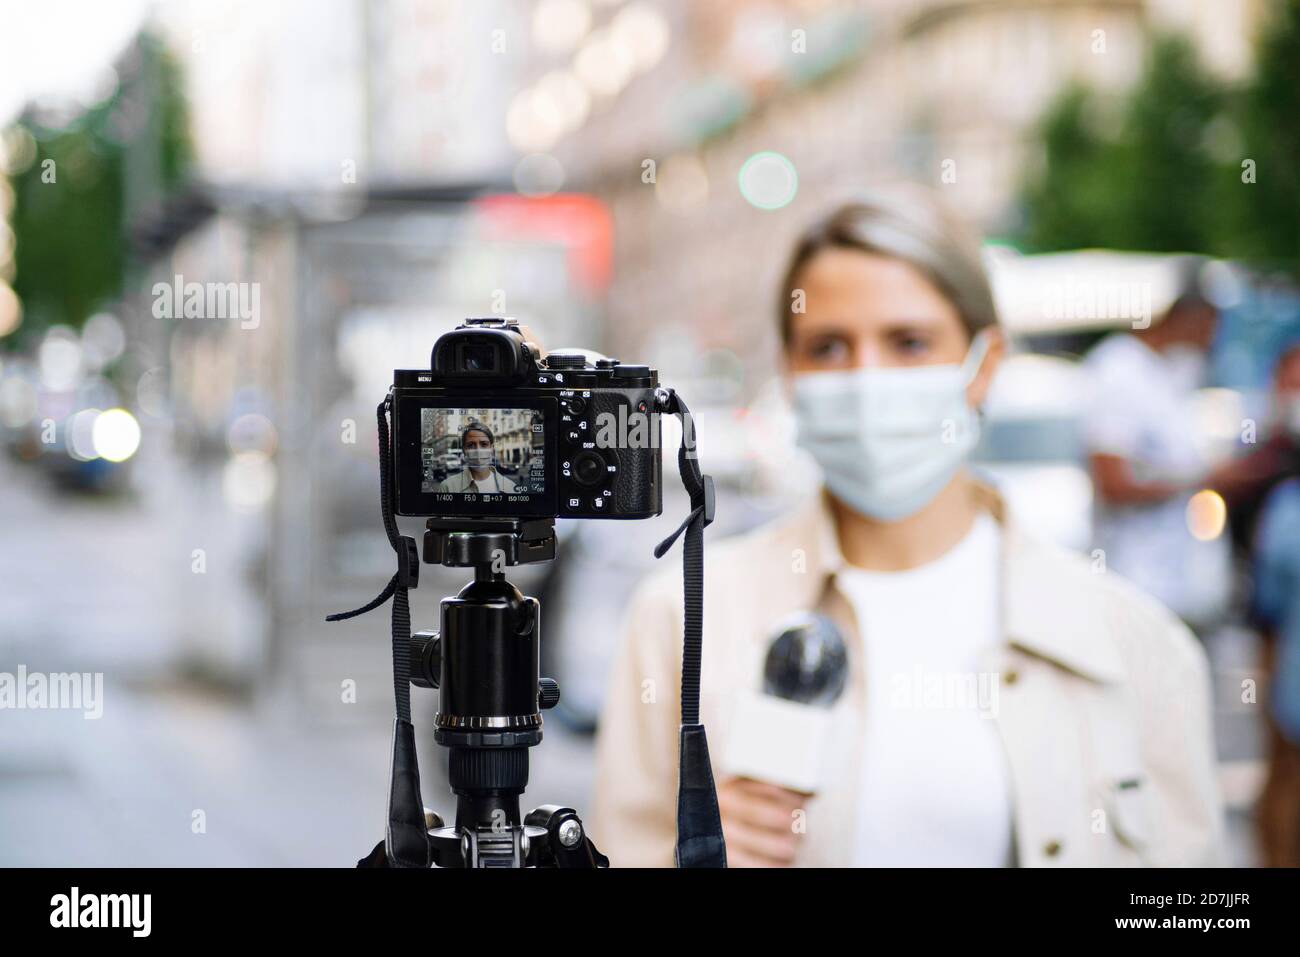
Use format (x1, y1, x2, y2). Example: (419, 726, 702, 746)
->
(325, 395, 432, 867)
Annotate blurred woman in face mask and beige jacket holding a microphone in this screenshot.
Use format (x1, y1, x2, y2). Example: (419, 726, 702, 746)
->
(593, 194, 1221, 866)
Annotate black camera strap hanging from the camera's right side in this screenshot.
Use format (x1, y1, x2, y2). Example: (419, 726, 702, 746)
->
(654, 389, 727, 867)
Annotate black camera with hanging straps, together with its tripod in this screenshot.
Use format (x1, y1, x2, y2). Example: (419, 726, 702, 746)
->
(326, 317, 727, 867)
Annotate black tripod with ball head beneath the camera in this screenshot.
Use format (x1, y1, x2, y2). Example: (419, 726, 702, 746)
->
(411, 519, 610, 867)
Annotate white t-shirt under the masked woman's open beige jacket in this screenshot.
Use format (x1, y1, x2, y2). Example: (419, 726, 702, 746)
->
(837, 512, 1011, 867)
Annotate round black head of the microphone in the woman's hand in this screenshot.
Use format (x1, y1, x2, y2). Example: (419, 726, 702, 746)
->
(763, 612, 849, 707)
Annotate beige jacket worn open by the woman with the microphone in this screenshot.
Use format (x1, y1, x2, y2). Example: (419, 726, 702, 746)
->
(590, 486, 1222, 866)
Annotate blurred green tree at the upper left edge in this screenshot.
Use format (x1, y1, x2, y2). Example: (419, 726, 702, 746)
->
(3, 34, 191, 348)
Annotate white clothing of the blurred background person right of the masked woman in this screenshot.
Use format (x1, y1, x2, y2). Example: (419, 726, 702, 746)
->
(1083, 333, 1231, 623)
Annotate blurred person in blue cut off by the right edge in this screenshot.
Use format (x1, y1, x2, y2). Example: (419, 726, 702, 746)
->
(1252, 346, 1300, 867)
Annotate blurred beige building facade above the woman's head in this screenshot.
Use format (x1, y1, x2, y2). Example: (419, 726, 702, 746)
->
(533, 0, 1266, 394)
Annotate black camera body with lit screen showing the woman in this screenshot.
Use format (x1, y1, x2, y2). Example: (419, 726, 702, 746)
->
(391, 317, 663, 519)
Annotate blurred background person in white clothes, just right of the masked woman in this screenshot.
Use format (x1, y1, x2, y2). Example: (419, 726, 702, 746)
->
(1084, 283, 1231, 628)
